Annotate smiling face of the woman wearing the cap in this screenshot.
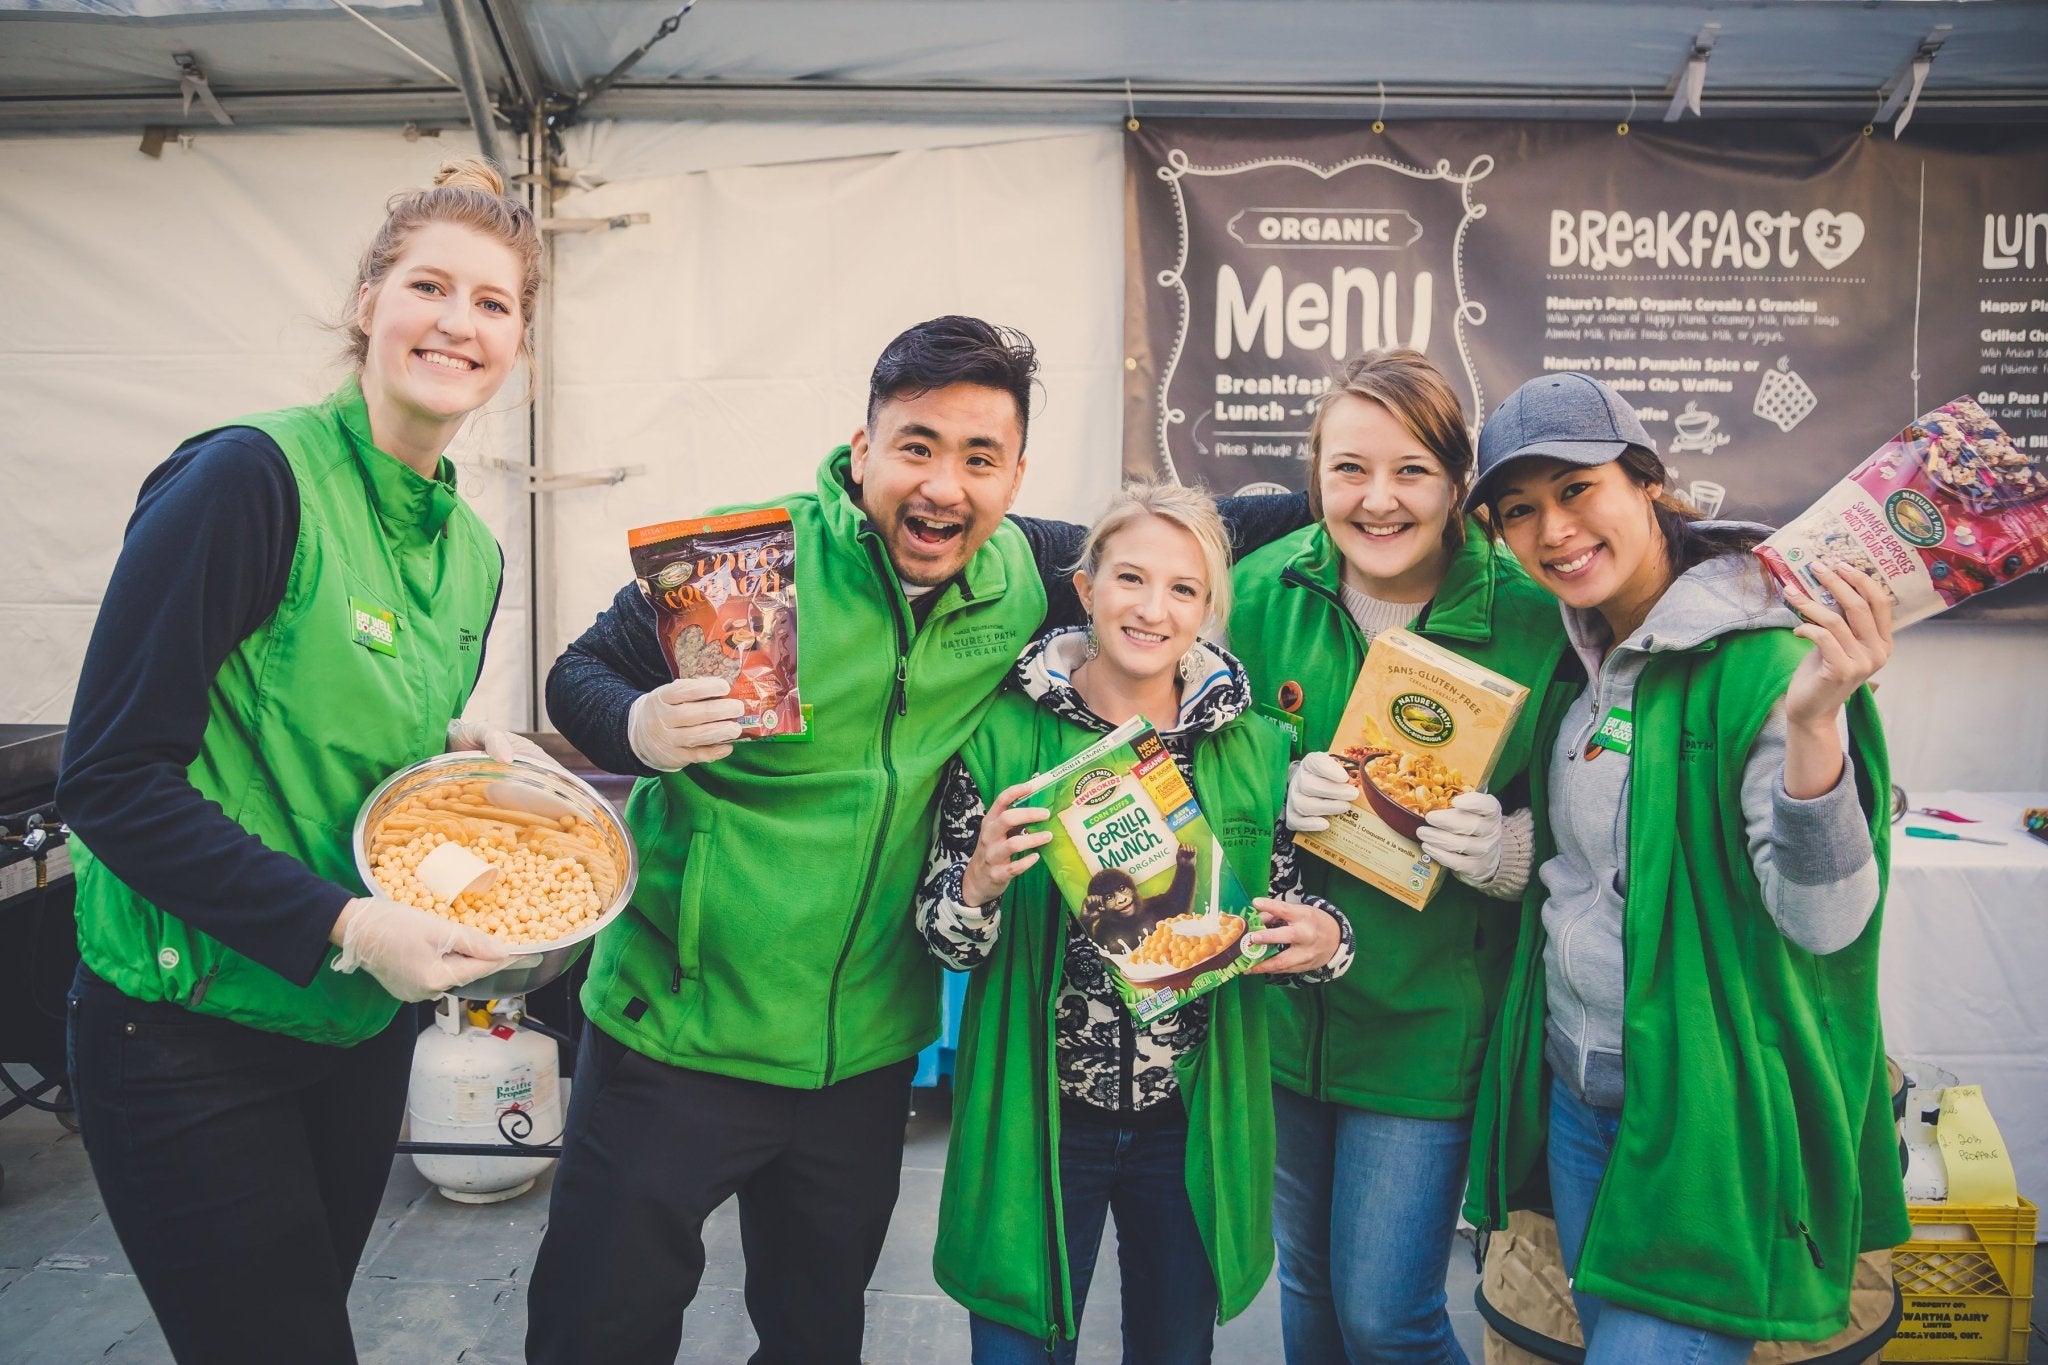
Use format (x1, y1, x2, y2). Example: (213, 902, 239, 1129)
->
(1493, 458, 1671, 639)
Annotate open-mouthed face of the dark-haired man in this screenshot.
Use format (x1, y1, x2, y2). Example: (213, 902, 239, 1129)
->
(852, 385, 1024, 587)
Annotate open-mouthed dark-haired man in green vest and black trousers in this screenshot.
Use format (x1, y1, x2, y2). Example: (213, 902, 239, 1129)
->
(526, 317, 1307, 1365)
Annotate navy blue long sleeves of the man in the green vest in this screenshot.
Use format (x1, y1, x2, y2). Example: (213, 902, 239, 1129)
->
(547, 493, 1309, 778)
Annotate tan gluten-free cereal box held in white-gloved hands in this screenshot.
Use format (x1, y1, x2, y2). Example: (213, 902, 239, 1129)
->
(1294, 630, 1528, 911)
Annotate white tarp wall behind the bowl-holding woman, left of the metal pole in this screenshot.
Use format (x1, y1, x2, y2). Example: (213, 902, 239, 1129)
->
(0, 131, 528, 724)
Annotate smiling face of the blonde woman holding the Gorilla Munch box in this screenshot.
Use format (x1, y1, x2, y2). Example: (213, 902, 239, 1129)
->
(1073, 512, 1208, 686)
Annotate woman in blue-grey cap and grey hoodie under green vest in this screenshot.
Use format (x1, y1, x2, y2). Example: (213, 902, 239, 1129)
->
(1468, 375, 1909, 1365)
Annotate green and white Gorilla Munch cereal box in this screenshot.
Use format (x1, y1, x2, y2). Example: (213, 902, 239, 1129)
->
(1024, 716, 1268, 1023)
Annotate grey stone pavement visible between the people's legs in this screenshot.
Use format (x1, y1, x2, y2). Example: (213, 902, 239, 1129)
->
(0, 1070, 1507, 1365)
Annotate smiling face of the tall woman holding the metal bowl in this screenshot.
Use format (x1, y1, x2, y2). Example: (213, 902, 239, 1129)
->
(356, 223, 524, 458)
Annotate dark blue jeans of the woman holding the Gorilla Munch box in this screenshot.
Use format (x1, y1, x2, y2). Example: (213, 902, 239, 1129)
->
(969, 1101, 1217, 1365)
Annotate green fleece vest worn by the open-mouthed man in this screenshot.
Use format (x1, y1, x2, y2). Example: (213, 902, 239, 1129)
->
(582, 446, 1044, 1089)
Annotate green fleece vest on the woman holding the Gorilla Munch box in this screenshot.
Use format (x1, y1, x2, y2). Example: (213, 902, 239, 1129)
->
(932, 690, 1292, 1342)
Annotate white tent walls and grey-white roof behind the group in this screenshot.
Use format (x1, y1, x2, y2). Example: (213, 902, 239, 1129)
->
(12, 0, 2048, 790)
